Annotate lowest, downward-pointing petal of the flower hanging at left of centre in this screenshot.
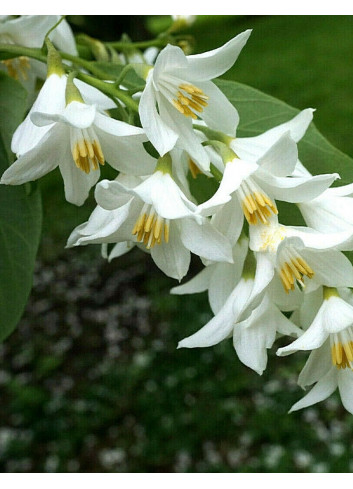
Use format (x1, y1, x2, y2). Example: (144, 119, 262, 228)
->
(151, 222, 190, 281)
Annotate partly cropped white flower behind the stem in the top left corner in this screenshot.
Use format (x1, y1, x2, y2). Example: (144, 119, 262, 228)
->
(0, 15, 77, 88)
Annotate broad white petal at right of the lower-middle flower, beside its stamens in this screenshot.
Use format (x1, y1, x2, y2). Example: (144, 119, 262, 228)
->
(180, 218, 233, 263)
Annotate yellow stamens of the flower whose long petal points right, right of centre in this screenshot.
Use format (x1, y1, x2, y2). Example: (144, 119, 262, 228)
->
(237, 178, 278, 225)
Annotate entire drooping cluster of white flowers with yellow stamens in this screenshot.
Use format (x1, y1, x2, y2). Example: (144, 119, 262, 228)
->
(0, 19, 353, 413)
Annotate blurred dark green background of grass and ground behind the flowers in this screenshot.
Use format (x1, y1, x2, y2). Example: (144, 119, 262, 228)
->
(0, 16, 353, 472)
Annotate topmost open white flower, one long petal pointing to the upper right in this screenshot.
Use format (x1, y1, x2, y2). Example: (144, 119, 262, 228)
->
(139, 30, 251, 170)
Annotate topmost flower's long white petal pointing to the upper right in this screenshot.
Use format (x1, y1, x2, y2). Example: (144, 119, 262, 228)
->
(187, 29, 251, 81)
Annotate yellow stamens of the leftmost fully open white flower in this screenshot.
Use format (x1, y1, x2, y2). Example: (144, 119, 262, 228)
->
(70, 127, 104, 173)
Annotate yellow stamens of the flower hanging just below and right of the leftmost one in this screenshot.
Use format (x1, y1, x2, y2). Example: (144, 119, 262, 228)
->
(132, 204, 169, 249)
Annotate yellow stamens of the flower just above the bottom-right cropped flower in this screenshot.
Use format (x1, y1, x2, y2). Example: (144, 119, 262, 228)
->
(279, 246, 314, 294)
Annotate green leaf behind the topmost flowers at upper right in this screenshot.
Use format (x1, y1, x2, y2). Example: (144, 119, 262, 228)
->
(216, 80, 353, 185)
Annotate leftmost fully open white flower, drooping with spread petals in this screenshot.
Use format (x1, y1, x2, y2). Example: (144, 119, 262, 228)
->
(1, 101, 154, 205)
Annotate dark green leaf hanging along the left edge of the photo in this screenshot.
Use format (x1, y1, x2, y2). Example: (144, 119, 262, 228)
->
(0, 73, 42, 341)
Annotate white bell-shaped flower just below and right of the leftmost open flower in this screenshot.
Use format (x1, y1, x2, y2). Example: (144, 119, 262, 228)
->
(69, 154, 232, 280)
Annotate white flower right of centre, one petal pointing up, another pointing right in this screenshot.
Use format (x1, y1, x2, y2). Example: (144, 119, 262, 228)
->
(198, 132, 337, 244)
